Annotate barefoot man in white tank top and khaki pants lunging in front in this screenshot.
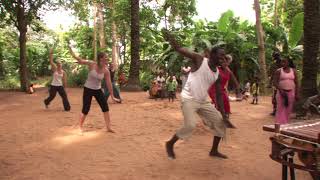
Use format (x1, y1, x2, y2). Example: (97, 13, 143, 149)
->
(163, 30, 233, 159)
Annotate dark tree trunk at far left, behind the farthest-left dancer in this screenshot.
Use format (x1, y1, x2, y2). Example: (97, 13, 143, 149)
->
(17, 1, 29, 92)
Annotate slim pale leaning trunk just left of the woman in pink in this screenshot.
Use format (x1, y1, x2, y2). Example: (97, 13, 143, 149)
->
(254, 0, 267, 93)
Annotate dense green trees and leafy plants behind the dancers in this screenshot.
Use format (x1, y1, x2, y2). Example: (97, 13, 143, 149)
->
(0, 0, 319, 96)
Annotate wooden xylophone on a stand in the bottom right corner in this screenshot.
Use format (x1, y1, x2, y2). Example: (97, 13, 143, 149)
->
(263, 119, 320, 180)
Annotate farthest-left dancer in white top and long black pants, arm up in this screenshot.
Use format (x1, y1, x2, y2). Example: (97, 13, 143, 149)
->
(44, 49, 70, 111)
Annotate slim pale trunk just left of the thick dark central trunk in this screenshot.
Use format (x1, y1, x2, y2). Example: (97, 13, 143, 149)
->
(111, 0, 119, 67)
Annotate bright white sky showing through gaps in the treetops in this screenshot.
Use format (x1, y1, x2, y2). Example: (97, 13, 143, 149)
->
(43, 0, 255, 30)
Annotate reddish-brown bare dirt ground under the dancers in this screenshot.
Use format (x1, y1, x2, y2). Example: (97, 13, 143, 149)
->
(0, 88, 311, 180)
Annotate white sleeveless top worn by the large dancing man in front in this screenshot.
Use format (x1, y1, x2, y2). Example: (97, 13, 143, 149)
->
(181, 58, 219, 101)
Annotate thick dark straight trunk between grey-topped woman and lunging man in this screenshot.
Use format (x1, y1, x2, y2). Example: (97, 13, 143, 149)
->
(125, 0, 141, 91)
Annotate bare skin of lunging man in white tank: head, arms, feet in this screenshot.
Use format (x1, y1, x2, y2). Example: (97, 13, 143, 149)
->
(162, 30, 235, 159)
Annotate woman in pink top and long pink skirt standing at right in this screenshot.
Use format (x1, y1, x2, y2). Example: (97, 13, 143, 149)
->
(274, 58, 299, 124)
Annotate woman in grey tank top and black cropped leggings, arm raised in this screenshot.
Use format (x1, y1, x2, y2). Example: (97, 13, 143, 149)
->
(69, 47, 120, 132)
